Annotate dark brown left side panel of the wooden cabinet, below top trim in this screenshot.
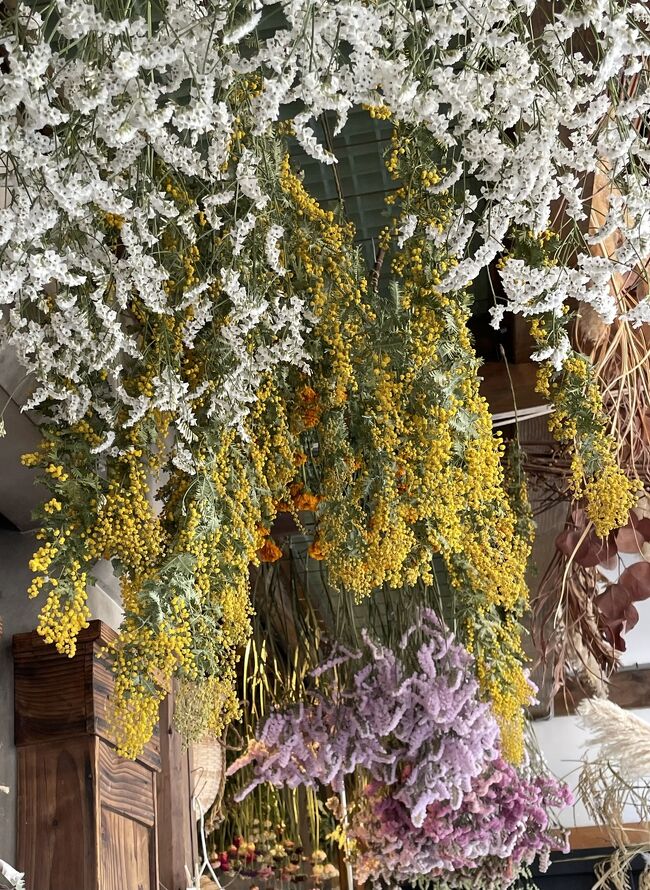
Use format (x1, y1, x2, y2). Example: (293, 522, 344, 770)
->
(17, 738, 98, 890)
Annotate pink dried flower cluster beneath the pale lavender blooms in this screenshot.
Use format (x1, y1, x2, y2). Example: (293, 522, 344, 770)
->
(350, 758, 572, 890)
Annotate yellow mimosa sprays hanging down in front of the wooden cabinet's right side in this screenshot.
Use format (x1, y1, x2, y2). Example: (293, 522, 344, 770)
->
(100, 420, 260, 757)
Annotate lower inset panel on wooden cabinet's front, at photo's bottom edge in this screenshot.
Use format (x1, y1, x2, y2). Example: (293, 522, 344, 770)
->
(99, 808, 158, 890)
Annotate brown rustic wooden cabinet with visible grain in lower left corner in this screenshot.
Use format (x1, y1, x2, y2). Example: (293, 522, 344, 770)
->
(13, 621, 161, 890)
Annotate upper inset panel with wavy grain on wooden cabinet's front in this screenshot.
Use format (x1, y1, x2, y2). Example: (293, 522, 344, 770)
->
(97, 740, 156, 826)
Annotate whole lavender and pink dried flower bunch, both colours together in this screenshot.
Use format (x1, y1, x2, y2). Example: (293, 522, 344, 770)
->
(228, 610, 570, 890)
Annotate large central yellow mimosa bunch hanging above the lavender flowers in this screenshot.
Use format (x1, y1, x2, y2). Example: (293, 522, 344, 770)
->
(274, 137, 530, 761)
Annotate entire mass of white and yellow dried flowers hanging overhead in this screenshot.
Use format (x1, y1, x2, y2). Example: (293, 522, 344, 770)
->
(0, 0, 648, 761)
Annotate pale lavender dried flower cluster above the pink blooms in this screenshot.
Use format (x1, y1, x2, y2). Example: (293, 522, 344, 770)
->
(229, 609, 498, 812)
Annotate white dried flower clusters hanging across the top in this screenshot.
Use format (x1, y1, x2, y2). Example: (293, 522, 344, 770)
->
(0, 0, 650, 442)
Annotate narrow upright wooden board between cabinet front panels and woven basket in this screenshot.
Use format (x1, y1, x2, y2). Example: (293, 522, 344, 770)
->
(156, 695, 198, 890)
